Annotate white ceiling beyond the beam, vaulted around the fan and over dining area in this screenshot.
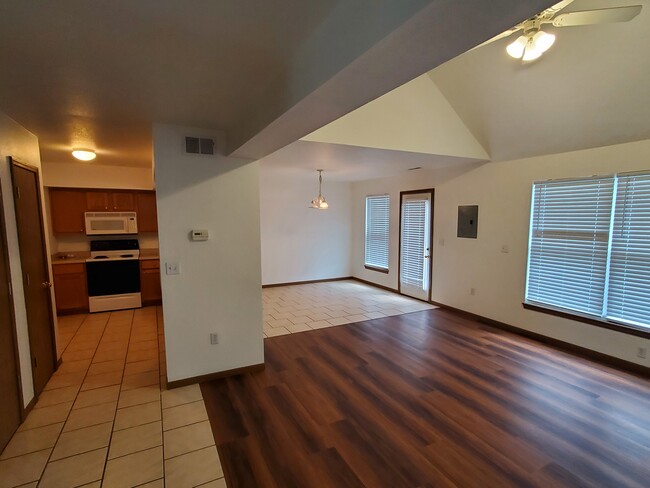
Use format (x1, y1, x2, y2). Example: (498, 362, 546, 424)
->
(262, 0, 650, 181)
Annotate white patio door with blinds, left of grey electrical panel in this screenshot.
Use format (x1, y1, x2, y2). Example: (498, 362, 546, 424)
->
(399, 191, 432, 300)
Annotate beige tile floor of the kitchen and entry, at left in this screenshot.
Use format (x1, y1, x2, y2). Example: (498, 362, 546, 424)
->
(0, 307, 226, 488)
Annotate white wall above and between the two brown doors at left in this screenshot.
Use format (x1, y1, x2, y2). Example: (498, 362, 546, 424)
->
(0, 113, 56, 405)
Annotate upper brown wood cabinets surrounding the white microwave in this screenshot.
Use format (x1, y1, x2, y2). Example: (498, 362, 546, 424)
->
(49, 188, 158, 234)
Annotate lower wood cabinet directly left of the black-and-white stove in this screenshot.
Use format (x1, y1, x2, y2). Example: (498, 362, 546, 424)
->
(52, 263, 88, 314)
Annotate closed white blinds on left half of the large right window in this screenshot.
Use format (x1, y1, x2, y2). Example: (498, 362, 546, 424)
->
(526, 178, 614, 315)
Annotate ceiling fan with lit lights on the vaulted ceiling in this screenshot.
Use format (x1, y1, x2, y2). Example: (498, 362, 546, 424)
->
(484, 0, 642, 62)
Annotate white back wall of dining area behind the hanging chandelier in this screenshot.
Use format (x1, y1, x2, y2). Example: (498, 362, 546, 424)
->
(260, 164, 352, 285)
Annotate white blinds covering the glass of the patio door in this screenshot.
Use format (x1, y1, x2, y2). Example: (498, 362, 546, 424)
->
(400, 200, 427, 287)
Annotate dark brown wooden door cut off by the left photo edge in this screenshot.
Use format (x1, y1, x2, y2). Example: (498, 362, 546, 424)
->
(0, 177, 23, 452)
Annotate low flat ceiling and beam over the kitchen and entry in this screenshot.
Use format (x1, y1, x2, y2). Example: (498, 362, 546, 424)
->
(0, 0, 553, 165)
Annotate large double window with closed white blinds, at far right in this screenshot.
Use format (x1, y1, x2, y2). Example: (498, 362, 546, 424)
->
(526, 174, 650, 328)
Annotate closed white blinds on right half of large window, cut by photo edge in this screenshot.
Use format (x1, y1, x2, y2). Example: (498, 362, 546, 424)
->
(607, 174, 650, 326)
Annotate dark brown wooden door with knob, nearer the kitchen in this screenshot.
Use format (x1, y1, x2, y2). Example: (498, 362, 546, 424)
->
(11, 161, 56, 395)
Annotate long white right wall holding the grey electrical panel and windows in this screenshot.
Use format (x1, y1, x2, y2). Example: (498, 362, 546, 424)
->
(352, 140, 650, 366)
